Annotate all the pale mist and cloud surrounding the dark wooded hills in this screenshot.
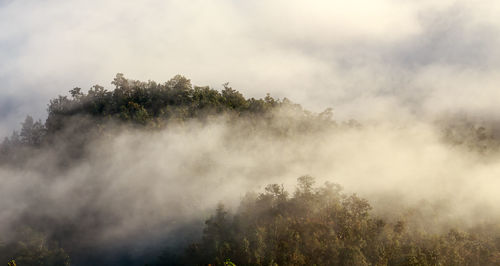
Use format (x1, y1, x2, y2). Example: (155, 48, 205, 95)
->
(0, 0, 500, 265)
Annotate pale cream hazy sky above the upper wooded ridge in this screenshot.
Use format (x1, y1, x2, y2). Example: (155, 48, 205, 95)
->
(0, 0, 500, 135)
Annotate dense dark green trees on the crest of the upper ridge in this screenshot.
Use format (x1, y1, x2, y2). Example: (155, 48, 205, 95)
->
(46, 73, 292, 131)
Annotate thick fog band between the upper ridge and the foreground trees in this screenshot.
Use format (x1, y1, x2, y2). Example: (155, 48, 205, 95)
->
(0, 105, 500, 259)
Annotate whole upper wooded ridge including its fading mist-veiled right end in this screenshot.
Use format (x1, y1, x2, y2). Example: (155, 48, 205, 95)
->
(0, 73, 336, 164)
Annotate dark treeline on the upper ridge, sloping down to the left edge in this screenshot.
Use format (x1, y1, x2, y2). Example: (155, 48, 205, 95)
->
(2, 74, 282, 152)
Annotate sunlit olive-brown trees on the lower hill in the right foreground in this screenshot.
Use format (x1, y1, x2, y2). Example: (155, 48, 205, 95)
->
(152, 176, 500, 266)
